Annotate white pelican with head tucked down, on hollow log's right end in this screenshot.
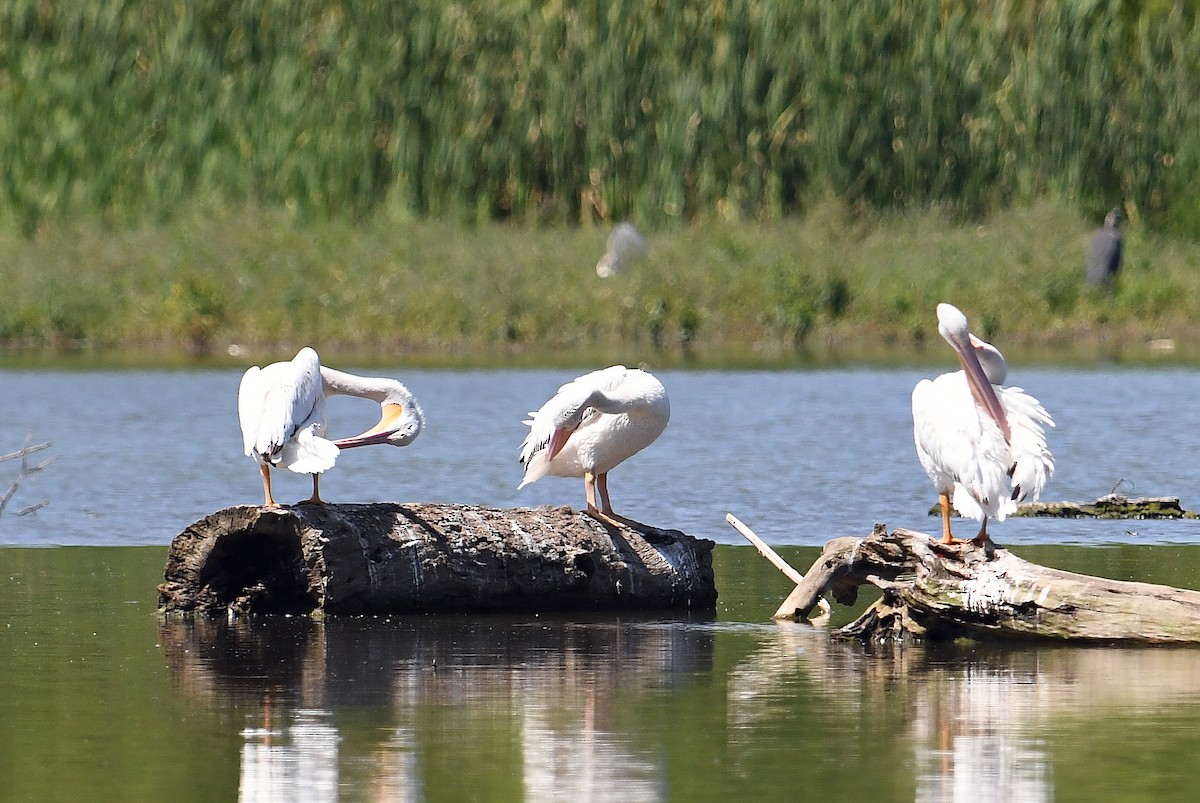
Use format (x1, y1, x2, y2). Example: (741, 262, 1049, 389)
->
(517, 365, 671, 525)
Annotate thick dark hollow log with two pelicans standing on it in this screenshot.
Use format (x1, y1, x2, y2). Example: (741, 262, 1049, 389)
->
(158, 503, 716, 615)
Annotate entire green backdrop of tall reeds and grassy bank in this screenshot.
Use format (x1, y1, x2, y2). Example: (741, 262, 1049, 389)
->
(0, 0, 1200, 364)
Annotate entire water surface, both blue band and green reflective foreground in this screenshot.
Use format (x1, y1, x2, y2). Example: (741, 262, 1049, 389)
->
(0, 371, 1200, 801)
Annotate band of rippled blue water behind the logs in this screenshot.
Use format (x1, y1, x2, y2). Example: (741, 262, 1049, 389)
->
(0, 370, 1200, 545)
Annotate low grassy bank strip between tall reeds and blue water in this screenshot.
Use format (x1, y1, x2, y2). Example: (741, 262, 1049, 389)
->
(7, 200, 1200, 365)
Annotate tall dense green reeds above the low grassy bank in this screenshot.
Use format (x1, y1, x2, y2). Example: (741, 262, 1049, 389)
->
(0, 0, 1200, 236)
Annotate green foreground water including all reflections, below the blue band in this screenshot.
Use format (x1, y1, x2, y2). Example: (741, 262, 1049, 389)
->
(0, 546, 1200, 801)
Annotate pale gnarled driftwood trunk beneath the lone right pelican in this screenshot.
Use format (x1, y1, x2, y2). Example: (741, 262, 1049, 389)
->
(748, 525, 1200, 643)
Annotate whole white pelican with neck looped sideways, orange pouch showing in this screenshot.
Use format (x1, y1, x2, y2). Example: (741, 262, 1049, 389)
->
(238, 347, 424, 508)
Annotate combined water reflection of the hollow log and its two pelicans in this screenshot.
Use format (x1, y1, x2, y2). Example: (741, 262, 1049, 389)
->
(160, 617, 713, 799)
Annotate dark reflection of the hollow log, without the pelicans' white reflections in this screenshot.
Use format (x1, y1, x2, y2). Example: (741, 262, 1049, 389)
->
(158, 612, 714, 714)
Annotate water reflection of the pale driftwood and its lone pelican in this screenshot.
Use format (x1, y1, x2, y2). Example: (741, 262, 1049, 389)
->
(728, 622, 1200, 801)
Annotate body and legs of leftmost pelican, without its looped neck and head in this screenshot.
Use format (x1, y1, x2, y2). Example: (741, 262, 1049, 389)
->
(238, 347, 338, 508)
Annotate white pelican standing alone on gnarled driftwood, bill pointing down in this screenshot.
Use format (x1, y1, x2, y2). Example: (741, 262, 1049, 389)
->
(912, 304, 1054, 544)
